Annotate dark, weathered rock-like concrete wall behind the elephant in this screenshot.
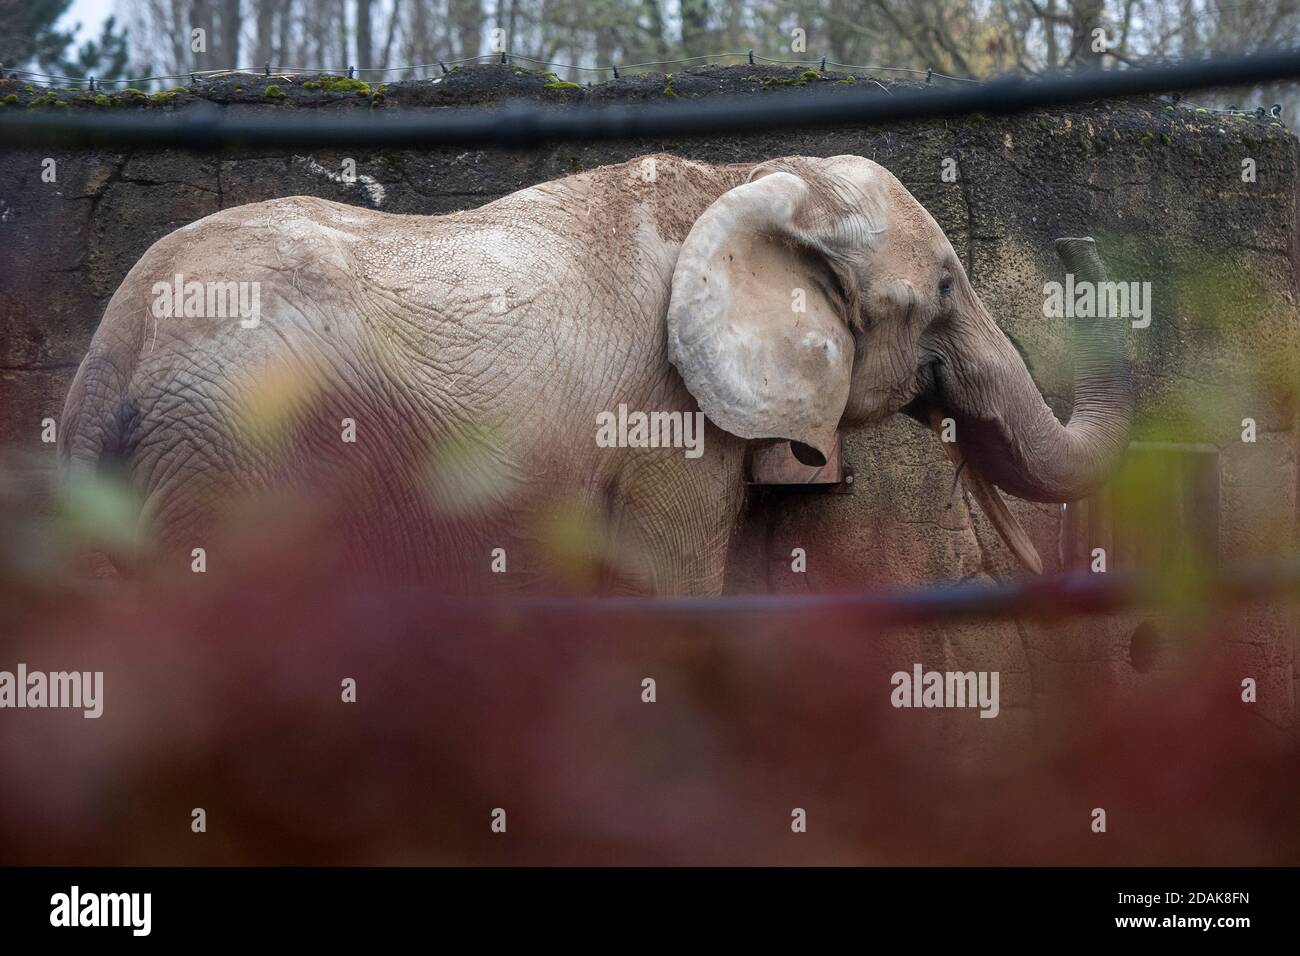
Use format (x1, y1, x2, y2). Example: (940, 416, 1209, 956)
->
(0, 66, 1300, 738)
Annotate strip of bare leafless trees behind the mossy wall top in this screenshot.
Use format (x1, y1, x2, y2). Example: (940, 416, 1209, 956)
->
(96, 0, 1300, 117)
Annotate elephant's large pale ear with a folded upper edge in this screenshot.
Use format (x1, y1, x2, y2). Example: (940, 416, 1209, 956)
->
(668, 166, 854, 462)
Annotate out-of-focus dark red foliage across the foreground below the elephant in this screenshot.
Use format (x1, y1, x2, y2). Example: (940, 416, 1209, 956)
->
(0, 538, 1300, 865)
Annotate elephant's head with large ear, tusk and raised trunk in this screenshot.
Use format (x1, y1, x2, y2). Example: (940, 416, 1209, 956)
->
(668, 156, 1132, 570)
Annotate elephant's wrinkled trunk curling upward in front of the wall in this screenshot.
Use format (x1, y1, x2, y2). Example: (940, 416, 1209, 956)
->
(937, 239, 1134, 502)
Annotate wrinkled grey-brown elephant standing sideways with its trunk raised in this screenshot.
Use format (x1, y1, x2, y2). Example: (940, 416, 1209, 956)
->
(59, 155, 1132, 594)
